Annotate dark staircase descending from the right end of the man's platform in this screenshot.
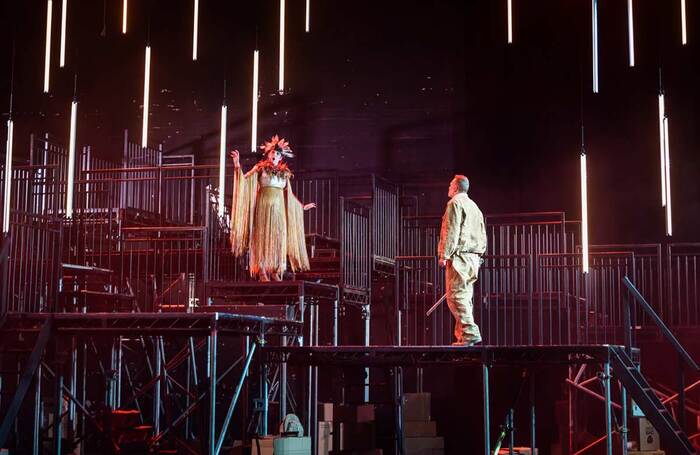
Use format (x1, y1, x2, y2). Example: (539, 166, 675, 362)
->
(610, 346, 696, 455)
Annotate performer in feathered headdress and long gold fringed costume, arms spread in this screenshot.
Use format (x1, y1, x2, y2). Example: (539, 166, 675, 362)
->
(231, 135, 316, 281)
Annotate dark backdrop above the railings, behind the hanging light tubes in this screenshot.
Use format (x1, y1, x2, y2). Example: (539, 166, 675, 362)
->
(0, 0, 700, 243)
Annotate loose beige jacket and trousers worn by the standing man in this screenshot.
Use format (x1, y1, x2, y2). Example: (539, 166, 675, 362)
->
(438, 193, 486, 343)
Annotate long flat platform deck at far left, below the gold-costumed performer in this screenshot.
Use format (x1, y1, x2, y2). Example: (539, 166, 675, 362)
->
(0, 313, 303, 336)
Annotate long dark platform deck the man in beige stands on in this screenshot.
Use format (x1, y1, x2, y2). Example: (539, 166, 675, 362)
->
(263, 345, 628, 367)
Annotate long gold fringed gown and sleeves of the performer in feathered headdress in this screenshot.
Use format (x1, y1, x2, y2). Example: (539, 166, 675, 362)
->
(231, 166, 309, 277)
